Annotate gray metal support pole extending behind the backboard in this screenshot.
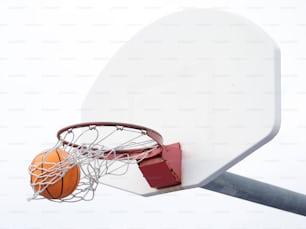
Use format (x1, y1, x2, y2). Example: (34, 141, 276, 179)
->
(202, 172, 306, 216)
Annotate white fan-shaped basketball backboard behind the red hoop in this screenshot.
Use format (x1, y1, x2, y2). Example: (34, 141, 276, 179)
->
(82, 9, 280, 196)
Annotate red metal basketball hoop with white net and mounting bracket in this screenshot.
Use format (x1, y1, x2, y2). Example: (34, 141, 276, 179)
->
(29, 122, 181, 202)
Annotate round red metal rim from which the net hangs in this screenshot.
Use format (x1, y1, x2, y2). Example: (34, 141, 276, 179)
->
(56, 122, 163, 158)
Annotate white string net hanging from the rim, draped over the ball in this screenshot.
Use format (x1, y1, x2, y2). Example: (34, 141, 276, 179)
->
(29, 125, 159, 202)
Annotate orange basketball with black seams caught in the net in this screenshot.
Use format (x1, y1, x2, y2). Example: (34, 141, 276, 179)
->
(30, 149, 80, 199)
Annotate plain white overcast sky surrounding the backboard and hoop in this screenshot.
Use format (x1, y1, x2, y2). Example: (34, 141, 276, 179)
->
(0, 0, 306, 229)
